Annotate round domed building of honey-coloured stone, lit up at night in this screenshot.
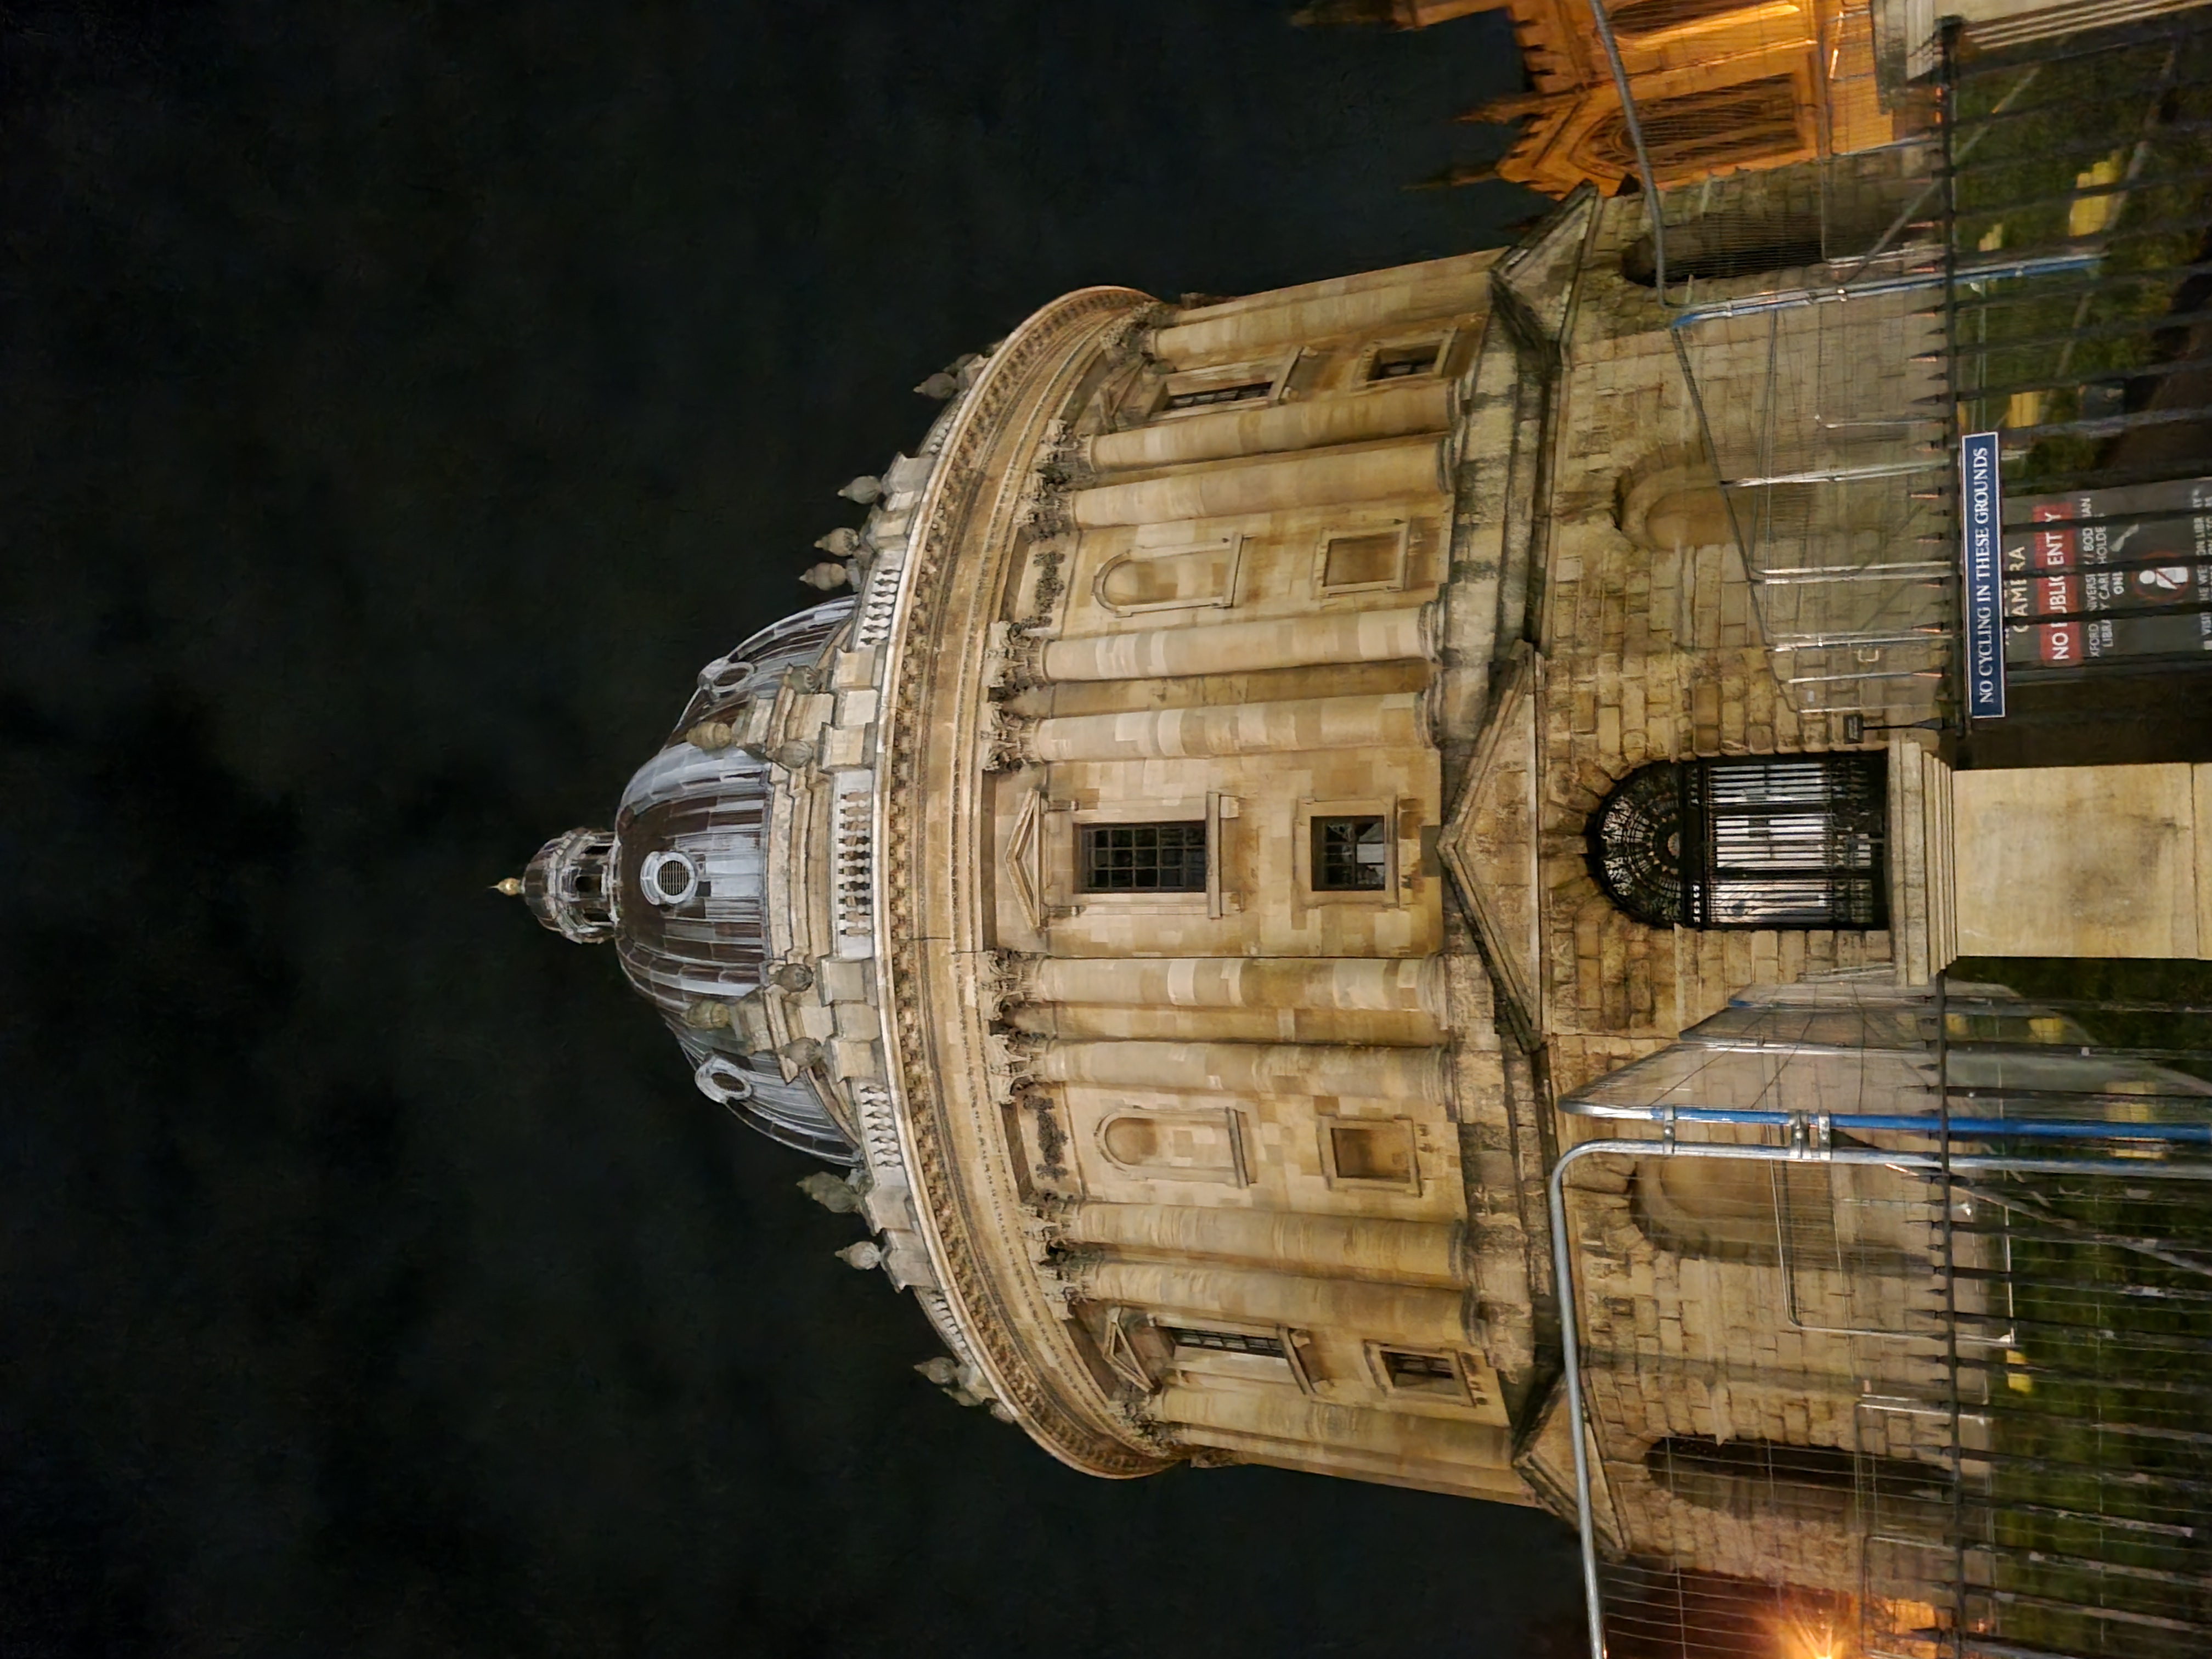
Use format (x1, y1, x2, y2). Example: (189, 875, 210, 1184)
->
(517, 9, 2212, 1652)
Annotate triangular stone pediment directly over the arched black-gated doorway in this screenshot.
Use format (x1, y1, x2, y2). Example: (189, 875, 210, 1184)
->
(1438, 646, 1544, 1031)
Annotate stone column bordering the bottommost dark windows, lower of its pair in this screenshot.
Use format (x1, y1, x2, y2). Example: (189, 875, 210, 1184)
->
(1077, 1261, 1480, 1347)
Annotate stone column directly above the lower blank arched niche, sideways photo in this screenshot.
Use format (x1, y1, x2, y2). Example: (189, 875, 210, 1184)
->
(1033, 1042, 1444, 1106)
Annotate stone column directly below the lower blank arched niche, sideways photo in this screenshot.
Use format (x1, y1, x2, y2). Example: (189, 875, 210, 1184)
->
(1062, 1201, 1471, 1288)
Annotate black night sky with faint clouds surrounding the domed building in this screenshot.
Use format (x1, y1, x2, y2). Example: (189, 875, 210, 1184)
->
(0, 0, 1573, 1659)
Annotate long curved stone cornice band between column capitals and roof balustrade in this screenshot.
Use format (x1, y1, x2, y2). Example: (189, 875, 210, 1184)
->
(874, 287, 1168, 1475)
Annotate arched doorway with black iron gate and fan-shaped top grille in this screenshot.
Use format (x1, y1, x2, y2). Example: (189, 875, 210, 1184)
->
(1590, 754, 1889, 929)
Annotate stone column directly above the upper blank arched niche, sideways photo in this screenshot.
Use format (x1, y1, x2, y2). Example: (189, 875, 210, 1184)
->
(1068, 438, 1449, 529)
